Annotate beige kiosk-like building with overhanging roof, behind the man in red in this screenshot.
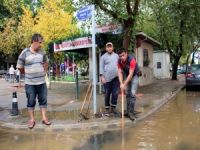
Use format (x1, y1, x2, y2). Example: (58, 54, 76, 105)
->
(135, 32, 160, 85)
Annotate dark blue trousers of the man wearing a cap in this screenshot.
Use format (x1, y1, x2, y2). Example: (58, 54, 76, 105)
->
(104, 77, 119, 109)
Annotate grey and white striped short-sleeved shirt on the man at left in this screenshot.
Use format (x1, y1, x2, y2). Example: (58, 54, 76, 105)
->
(17, 48, 47, 85)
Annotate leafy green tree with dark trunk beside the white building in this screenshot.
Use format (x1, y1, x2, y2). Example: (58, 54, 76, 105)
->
(149, 0, 200, 80)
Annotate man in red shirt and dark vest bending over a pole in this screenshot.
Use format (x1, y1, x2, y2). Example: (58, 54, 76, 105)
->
(117, 48, 139, 120)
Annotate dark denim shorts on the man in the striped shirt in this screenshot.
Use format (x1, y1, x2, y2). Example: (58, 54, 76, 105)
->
(25, 83, 47, 109)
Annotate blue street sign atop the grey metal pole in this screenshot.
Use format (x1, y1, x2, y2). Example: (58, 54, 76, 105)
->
(76, 6, 92, 21)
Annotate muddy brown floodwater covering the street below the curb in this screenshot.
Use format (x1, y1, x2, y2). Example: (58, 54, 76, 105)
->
(0, 90, 200, 150)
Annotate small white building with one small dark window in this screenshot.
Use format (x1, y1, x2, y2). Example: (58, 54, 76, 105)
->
(153, 51, 170, 79)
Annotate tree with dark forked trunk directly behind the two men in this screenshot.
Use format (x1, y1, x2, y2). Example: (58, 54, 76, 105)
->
(76, 0, 140, 49)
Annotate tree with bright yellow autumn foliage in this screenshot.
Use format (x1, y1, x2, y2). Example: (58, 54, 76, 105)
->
(33, 0, 78, 46)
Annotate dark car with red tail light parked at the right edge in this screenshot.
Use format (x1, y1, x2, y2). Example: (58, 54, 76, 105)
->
(186, 64, 200, 88)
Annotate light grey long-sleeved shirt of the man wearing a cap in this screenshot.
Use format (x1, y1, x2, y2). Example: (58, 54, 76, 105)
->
(100, 52, 119, 82)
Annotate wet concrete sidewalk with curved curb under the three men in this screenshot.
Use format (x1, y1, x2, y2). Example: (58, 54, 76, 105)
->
(0, 76, 185, 131)
